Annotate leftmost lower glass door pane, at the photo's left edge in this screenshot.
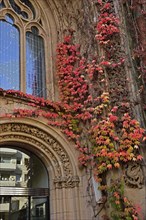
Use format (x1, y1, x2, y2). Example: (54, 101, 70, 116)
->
(0, 196, 10, 220)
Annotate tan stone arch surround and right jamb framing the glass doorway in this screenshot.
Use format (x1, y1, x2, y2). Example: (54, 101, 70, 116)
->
(0, 118, 82, 220)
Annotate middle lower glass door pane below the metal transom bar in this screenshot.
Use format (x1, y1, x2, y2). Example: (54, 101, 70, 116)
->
(10, 197, 29, 220)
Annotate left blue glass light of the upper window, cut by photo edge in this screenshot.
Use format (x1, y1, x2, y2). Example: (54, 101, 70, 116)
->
(0, 16, 20, 90)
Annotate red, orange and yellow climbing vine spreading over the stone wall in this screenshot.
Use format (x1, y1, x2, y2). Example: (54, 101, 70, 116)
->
(0, 0, 144, 220)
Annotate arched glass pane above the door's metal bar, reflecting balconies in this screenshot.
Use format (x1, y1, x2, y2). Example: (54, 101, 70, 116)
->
(0, 147, 48, 188)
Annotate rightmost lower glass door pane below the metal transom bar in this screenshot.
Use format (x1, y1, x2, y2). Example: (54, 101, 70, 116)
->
(30, 197, 48, 220)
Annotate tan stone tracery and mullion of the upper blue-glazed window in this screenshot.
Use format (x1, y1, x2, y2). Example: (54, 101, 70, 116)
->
(0, 0, 50, 98)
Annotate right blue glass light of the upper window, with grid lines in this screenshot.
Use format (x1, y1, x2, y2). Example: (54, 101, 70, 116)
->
(26, 29, 46, 97)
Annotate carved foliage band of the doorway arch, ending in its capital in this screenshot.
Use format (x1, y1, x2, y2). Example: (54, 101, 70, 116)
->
(0, 123, 79, 188)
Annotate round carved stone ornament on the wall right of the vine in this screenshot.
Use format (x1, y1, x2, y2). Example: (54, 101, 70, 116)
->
(124, 163, 144, 189)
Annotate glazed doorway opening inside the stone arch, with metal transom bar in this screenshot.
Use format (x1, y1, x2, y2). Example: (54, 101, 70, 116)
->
(0, 146, 49, 220)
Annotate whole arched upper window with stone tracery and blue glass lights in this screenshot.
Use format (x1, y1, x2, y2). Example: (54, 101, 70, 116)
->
(0, 0, 46, 97)
